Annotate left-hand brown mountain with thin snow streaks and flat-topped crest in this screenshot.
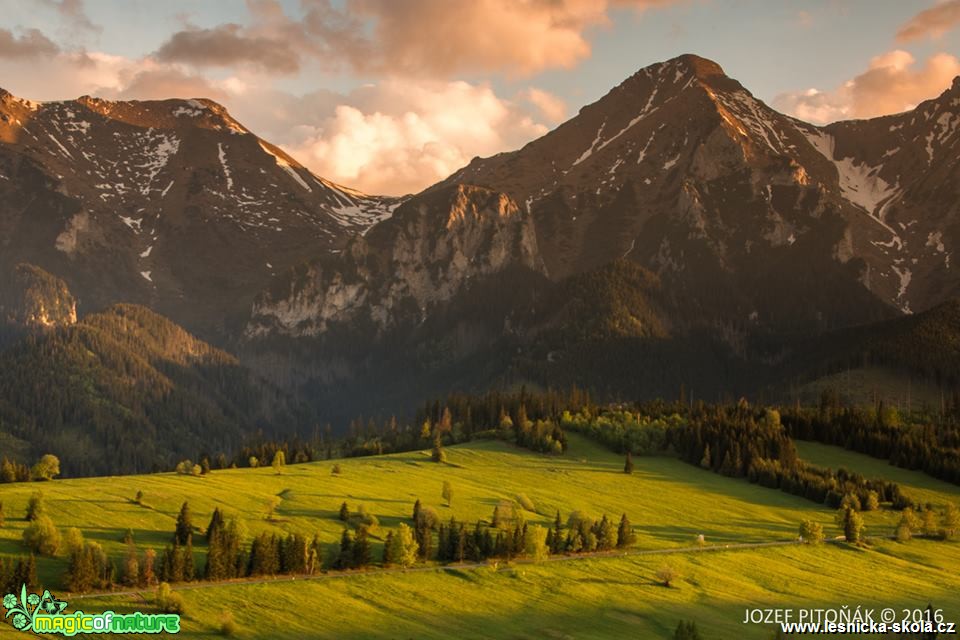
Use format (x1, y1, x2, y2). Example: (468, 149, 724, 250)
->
(0, 91, 400, 339)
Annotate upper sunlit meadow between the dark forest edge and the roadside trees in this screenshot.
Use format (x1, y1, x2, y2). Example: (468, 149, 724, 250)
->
(0, 436, 830, 586)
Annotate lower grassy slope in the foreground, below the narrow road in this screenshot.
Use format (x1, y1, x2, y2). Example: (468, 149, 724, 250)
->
(71, 541, 960, 640)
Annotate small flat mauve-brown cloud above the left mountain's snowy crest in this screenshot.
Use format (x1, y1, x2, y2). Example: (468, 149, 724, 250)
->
(154, 24, 300, 73)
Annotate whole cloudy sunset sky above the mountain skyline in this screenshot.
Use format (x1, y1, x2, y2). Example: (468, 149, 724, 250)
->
(0, 0, 960, 194)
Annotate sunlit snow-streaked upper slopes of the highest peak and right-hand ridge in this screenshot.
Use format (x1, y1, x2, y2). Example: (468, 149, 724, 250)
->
(447, 55, 960, 328)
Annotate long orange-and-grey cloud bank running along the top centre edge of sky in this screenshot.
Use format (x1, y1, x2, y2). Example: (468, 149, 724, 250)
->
(156, 0, 677, 77)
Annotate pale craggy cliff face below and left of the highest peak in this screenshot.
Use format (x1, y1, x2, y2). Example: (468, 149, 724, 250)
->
(247, 185, 544, 337)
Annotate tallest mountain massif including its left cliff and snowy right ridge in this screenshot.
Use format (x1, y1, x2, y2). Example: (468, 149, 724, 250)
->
(238, 55, 960, 416)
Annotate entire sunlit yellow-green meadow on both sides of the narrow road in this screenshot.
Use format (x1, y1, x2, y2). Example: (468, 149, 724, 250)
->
(0, 435, 960, 638)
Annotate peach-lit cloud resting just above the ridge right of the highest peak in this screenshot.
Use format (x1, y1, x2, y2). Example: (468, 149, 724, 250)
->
(773, 49, 960, 123)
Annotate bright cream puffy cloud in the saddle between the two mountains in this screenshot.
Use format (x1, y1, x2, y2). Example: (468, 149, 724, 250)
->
(283, 79, 547, 194)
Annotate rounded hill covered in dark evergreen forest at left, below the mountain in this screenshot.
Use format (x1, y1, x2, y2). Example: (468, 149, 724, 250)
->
(0, 305, 311, 476)
